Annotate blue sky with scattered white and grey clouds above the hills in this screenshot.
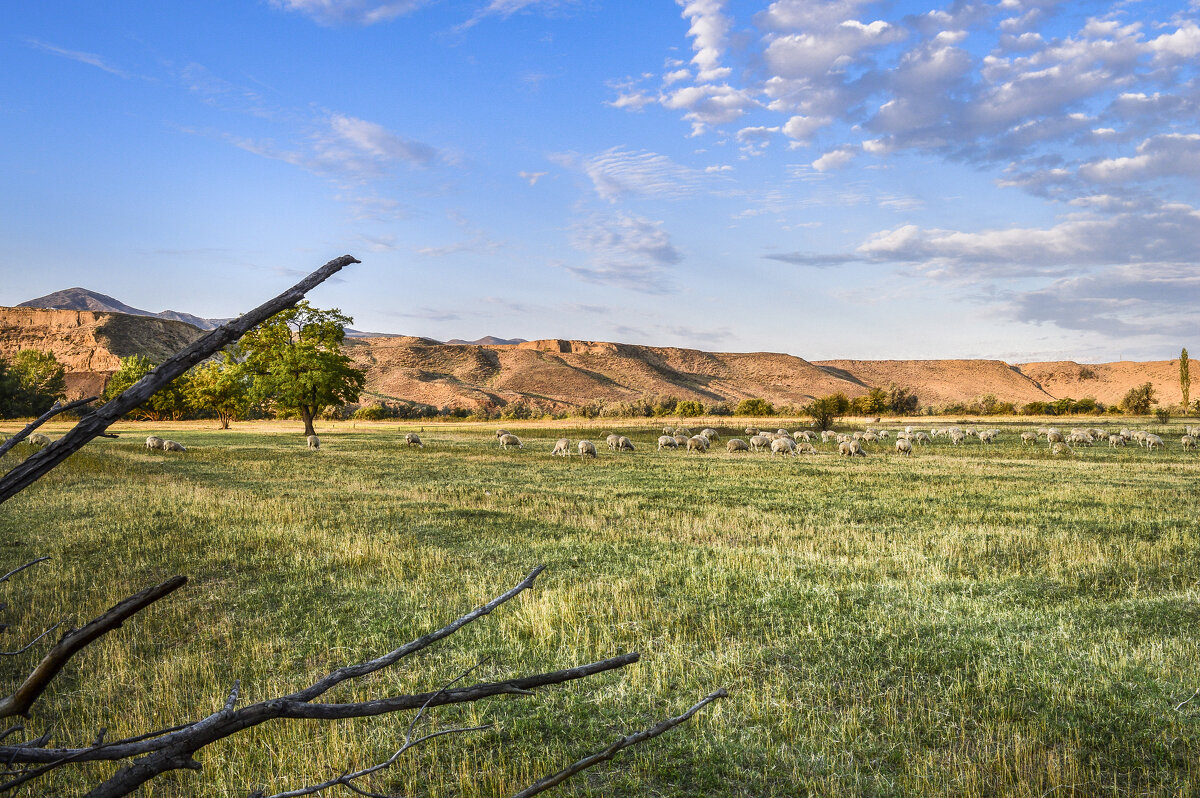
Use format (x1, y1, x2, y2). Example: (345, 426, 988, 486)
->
(0, 0, 1200, 362)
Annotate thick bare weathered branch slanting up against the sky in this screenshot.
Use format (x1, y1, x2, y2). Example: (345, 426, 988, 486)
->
(0, 254, 361, 503)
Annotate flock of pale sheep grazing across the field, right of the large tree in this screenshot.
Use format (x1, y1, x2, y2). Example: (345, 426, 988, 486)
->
(480, 426, 1200, 457)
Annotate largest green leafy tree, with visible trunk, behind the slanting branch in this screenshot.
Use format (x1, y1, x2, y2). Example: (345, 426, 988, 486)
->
(241, 301, 366, 436)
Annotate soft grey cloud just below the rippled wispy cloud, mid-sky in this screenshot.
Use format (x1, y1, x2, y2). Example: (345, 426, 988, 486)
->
(566, 212, 683, 294)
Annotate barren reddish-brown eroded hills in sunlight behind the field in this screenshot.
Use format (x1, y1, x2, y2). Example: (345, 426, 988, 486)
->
(0, 300, 1180, 409)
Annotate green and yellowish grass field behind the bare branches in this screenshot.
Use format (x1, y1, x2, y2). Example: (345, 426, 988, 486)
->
(0, 421, 1200, 798)
